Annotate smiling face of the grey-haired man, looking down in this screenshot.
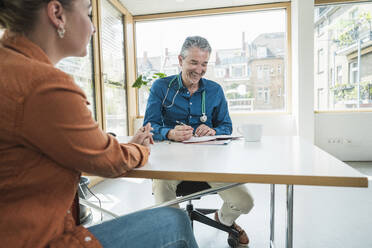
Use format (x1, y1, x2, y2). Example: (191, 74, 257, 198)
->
(178, 47, 209, 86)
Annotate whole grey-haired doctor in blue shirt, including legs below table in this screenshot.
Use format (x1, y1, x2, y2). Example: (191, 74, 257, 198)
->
(144, 36, 253, 245)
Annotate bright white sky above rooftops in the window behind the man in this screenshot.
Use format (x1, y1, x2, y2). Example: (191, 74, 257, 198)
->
(136, 9, 286, 57)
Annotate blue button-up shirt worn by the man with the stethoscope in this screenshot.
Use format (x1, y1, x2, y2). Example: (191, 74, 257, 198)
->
(144, 72, 232, 140)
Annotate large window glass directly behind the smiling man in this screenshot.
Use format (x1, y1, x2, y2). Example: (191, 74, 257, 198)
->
(136, 9, 287, 115)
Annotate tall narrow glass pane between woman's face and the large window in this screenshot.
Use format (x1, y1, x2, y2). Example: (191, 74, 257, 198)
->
(101, 0, 128, 137)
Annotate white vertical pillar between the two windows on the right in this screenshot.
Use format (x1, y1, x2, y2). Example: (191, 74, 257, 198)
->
(291, 0, 314, 143)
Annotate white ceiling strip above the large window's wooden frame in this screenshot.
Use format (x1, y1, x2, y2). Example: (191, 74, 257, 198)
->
(119, 0, 289, 15)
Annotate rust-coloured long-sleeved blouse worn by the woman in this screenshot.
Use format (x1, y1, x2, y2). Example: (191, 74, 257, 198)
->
(0, 33, 149, 248)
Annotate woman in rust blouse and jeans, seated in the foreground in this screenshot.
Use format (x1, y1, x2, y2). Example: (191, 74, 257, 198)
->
(0, 0, 197, 248)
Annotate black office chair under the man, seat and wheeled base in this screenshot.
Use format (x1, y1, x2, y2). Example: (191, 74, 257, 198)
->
(176, 181, 239, 247)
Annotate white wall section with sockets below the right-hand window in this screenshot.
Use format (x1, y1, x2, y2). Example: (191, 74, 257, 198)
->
(315, 112, 372, 161)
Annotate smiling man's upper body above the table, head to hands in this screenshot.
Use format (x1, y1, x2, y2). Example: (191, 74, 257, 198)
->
(144, 36, 232, 141)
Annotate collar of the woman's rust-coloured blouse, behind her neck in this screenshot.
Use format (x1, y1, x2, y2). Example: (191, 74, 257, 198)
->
(1, 31, 52, 64)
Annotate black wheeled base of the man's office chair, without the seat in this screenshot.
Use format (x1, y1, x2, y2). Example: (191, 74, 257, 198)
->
(186, 203, 239, 248)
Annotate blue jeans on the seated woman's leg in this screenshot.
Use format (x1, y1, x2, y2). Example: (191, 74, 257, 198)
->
(88, 207, 198, 248)
